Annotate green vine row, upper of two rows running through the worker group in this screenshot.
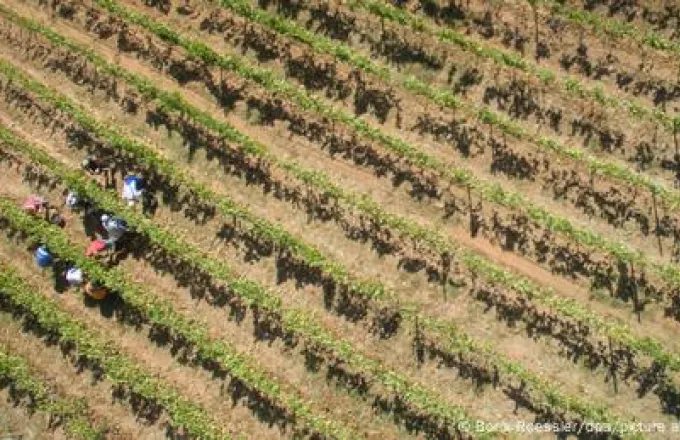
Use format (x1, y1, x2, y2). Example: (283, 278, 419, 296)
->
(0, 125, 500, 438)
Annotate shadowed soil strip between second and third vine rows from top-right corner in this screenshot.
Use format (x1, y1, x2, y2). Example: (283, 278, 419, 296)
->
(248, 2, 674, 188)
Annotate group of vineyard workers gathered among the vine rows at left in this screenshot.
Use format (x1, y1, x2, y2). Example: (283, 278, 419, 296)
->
(29, 153, 145, 299)
